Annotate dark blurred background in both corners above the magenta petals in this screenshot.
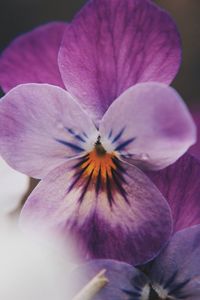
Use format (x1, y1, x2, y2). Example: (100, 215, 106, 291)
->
(0, 0, 200, 105)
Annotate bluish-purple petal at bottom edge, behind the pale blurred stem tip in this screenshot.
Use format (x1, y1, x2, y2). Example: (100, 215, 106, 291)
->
(71, 259, 149, 300)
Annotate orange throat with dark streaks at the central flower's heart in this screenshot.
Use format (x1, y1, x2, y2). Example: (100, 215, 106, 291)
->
(69, 138, 128, 205)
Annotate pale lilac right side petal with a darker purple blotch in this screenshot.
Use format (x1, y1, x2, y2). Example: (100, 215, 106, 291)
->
(100, 83, 196, 169)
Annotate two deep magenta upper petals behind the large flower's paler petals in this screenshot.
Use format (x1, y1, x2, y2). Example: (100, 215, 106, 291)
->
(0, 0, 181, 122)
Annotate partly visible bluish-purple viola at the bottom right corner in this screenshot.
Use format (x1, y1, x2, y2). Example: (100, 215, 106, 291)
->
(73, 225, 200, 300)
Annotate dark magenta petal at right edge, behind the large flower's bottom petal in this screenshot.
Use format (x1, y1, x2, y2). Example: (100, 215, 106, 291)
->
(148, 154, 200, 231)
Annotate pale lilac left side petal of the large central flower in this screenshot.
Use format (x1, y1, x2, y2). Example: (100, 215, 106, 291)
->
(0, 84, 97, 178)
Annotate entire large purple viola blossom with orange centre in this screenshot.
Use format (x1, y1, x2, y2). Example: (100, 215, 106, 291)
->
(0, 0, 196, 264)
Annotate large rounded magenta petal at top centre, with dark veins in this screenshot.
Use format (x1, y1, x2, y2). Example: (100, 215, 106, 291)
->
(59, 0, 181, 120)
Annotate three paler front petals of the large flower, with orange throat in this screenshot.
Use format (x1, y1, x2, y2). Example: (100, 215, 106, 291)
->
(0, 83, 195, 264)
